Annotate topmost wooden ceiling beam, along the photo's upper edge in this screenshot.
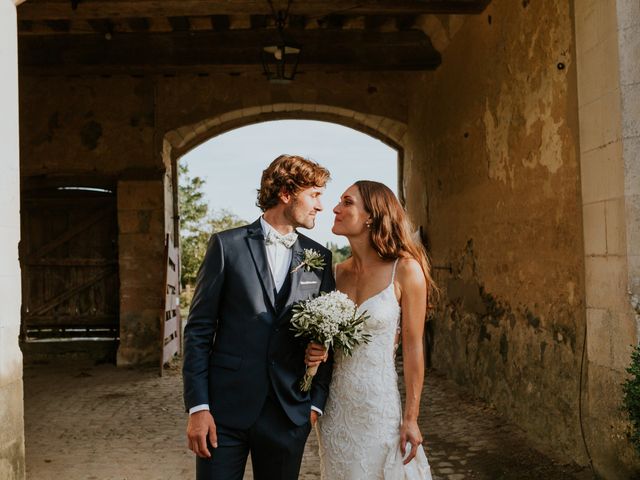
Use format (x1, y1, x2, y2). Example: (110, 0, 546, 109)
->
(18, 0, 490, 20)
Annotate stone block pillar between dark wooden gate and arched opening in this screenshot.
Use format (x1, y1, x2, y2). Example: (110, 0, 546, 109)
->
(117, 179, 165, 366)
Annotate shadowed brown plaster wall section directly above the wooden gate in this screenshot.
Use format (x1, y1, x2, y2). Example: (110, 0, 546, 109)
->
(20, 76, 160, 178)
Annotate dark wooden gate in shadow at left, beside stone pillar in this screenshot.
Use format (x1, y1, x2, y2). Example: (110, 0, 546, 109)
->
(20, 187, 119, 342)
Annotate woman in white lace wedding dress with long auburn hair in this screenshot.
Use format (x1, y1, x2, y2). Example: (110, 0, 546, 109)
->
(306, 181, 434, 480)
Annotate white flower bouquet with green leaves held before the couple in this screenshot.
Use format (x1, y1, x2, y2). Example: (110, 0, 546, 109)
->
(291, 290, 371, 392)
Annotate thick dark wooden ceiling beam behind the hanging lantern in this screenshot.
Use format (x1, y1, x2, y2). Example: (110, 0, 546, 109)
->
(18, 30, 440, 73)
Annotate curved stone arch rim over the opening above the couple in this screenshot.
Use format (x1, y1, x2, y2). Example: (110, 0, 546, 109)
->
(163, 103, 407, 159)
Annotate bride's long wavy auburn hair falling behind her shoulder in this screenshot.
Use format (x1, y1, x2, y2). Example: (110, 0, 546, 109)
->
(354, 180, 438, 309)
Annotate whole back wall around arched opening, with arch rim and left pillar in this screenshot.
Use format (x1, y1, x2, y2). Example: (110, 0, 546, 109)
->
(20, 73, 411, 365)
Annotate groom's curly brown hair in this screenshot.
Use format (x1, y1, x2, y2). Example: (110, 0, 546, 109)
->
(256, 155, 331, 212)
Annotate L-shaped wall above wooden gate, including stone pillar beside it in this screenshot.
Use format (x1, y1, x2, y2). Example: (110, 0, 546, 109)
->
(20, 76, 165, 365)
